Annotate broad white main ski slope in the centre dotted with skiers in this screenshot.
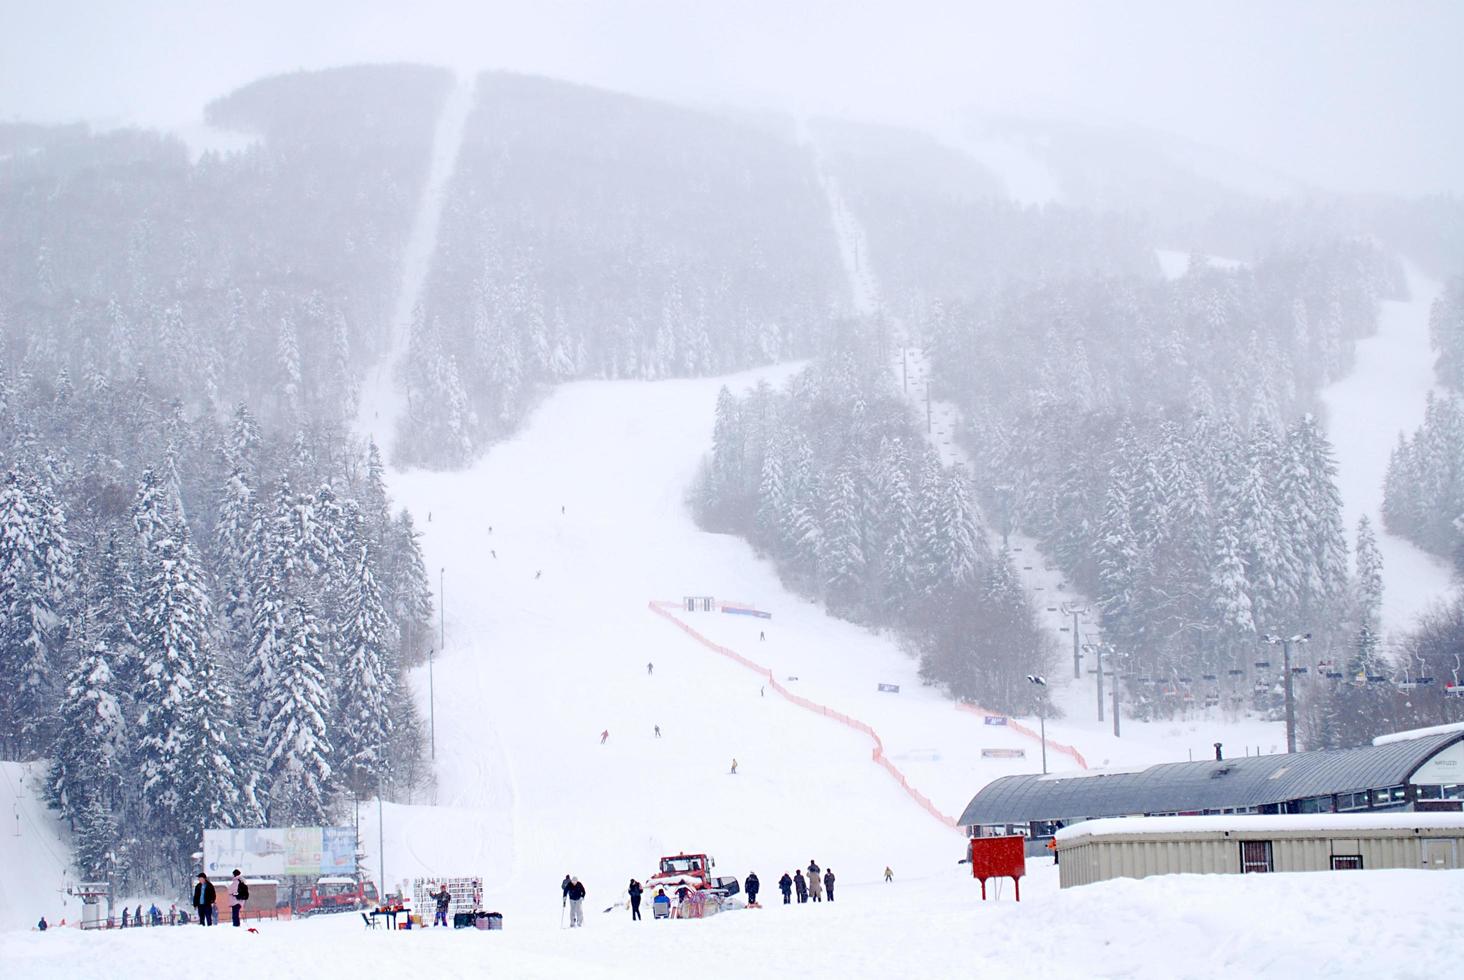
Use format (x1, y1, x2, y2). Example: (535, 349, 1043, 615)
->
(363, 368, 1054, 904)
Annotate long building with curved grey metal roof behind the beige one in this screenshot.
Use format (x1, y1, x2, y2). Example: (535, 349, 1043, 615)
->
(960, 731, 1464, 836)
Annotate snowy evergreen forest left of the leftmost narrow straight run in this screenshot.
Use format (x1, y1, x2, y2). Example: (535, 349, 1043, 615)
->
(0, 67, 449, 889)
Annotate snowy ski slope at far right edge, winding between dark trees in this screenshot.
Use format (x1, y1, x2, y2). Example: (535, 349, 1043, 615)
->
(1322, 264, 1452, 633)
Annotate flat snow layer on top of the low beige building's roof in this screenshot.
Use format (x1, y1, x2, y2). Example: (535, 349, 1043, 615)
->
(1057, 812, 1464, 841)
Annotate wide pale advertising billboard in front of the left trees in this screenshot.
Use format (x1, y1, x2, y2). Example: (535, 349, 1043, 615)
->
(203, 826, 356, 877)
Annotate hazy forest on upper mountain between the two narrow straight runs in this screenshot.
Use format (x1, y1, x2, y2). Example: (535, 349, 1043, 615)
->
(401, 73, 846, 466)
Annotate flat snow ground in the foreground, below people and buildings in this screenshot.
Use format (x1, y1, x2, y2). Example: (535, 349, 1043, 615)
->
(0, 861, 1464, 980)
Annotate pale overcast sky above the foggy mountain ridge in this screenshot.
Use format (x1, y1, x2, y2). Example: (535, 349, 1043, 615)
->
(0, 0, 1464, 193)
